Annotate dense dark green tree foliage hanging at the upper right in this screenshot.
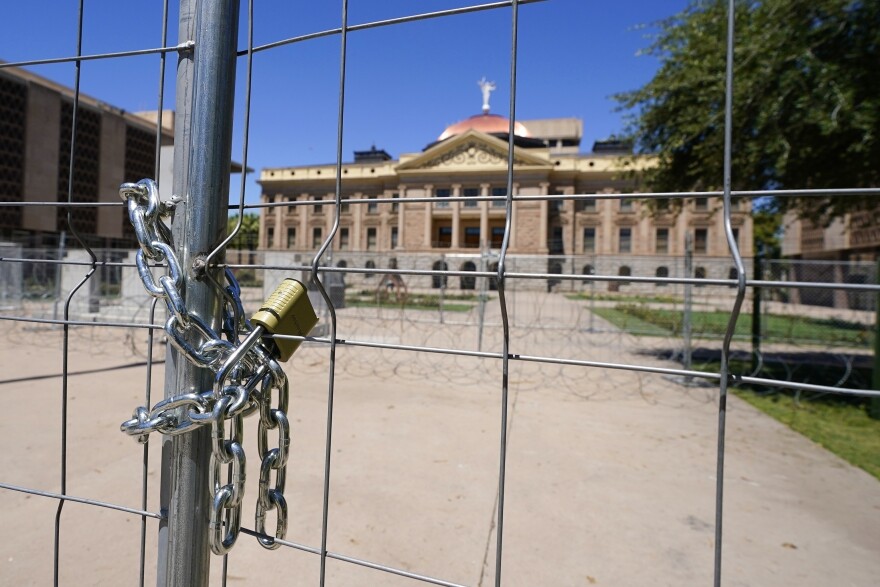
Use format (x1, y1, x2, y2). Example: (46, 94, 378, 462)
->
(616, 0, 880, 222)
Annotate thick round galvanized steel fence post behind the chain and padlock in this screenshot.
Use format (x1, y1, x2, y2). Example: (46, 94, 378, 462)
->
(157, 0, 239, 587)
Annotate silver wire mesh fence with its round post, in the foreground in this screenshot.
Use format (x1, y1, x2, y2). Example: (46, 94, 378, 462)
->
(0, 0, 880, 586)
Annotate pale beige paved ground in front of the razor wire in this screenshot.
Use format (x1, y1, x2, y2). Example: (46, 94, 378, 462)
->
(0, 294, 880, 587)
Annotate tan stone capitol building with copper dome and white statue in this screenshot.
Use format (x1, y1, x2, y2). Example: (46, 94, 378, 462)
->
(259, 86, 752, 289)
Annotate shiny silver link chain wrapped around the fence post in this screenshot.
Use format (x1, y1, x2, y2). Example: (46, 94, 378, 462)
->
(119, 179, 290, 554)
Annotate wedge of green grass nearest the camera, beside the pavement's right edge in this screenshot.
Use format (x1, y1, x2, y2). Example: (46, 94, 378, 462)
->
(734, 389, 880, 480)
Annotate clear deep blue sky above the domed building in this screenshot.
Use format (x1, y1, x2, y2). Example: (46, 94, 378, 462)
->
(0, 0, 687, 202)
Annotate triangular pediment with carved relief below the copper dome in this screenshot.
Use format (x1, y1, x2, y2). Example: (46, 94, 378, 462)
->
(397, 130, 550, 172)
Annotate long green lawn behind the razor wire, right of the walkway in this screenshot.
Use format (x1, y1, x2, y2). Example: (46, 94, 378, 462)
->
(595, 304, 874, 347)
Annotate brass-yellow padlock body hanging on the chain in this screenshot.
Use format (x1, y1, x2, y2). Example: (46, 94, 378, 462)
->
(251, 277, 318, 362)
